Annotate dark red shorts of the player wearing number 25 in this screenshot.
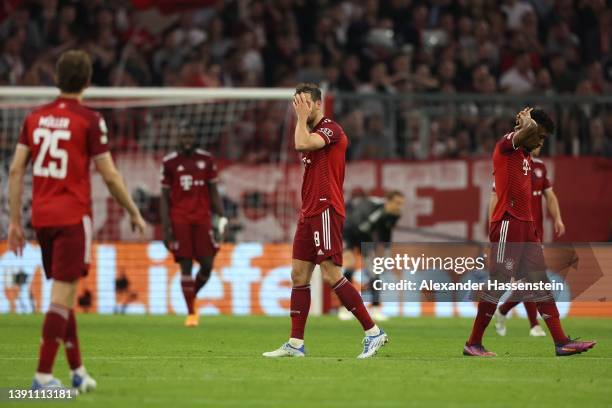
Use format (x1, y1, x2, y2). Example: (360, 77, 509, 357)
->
(36, 216, 92, 282)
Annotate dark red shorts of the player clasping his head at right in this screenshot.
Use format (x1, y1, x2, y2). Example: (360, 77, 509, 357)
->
(489, 213, 546, 279)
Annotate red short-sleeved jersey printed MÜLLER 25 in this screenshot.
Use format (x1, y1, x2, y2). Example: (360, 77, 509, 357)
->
(18, 98, 108, 228)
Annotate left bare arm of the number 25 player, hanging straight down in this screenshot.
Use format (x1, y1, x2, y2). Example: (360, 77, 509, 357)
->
(8, 144, 30, 255)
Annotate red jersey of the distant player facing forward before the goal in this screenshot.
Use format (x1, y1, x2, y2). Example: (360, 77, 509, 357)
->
(161, 149, 217, 225)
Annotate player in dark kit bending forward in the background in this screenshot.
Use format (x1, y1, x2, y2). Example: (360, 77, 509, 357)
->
(338, 190, 406, 321)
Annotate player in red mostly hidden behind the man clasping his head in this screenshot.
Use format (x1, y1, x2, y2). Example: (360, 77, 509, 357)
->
(489, 147, 565, 337)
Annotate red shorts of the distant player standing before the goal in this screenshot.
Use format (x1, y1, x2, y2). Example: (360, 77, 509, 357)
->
(172, 223, 219, 261)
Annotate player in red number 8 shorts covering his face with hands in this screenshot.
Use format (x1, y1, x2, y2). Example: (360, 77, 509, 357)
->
(263, 84, 388, 358)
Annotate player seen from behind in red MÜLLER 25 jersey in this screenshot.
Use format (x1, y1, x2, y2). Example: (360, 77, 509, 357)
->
(8, 51, 145, 392)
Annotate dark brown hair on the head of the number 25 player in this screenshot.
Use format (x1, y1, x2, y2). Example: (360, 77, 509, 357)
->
(55, 50, 92, 93)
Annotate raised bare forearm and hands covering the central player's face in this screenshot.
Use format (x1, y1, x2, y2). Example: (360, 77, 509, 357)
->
(293, 93, 325, 152)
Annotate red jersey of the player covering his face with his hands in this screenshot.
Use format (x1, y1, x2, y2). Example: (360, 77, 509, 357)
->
(300, 117, 348, 218)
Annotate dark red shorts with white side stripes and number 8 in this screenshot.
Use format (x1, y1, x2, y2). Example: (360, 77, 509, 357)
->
(293, 207, 344, 266)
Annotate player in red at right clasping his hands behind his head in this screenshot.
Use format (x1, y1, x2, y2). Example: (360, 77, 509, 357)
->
(463, 108, 596, 356)
